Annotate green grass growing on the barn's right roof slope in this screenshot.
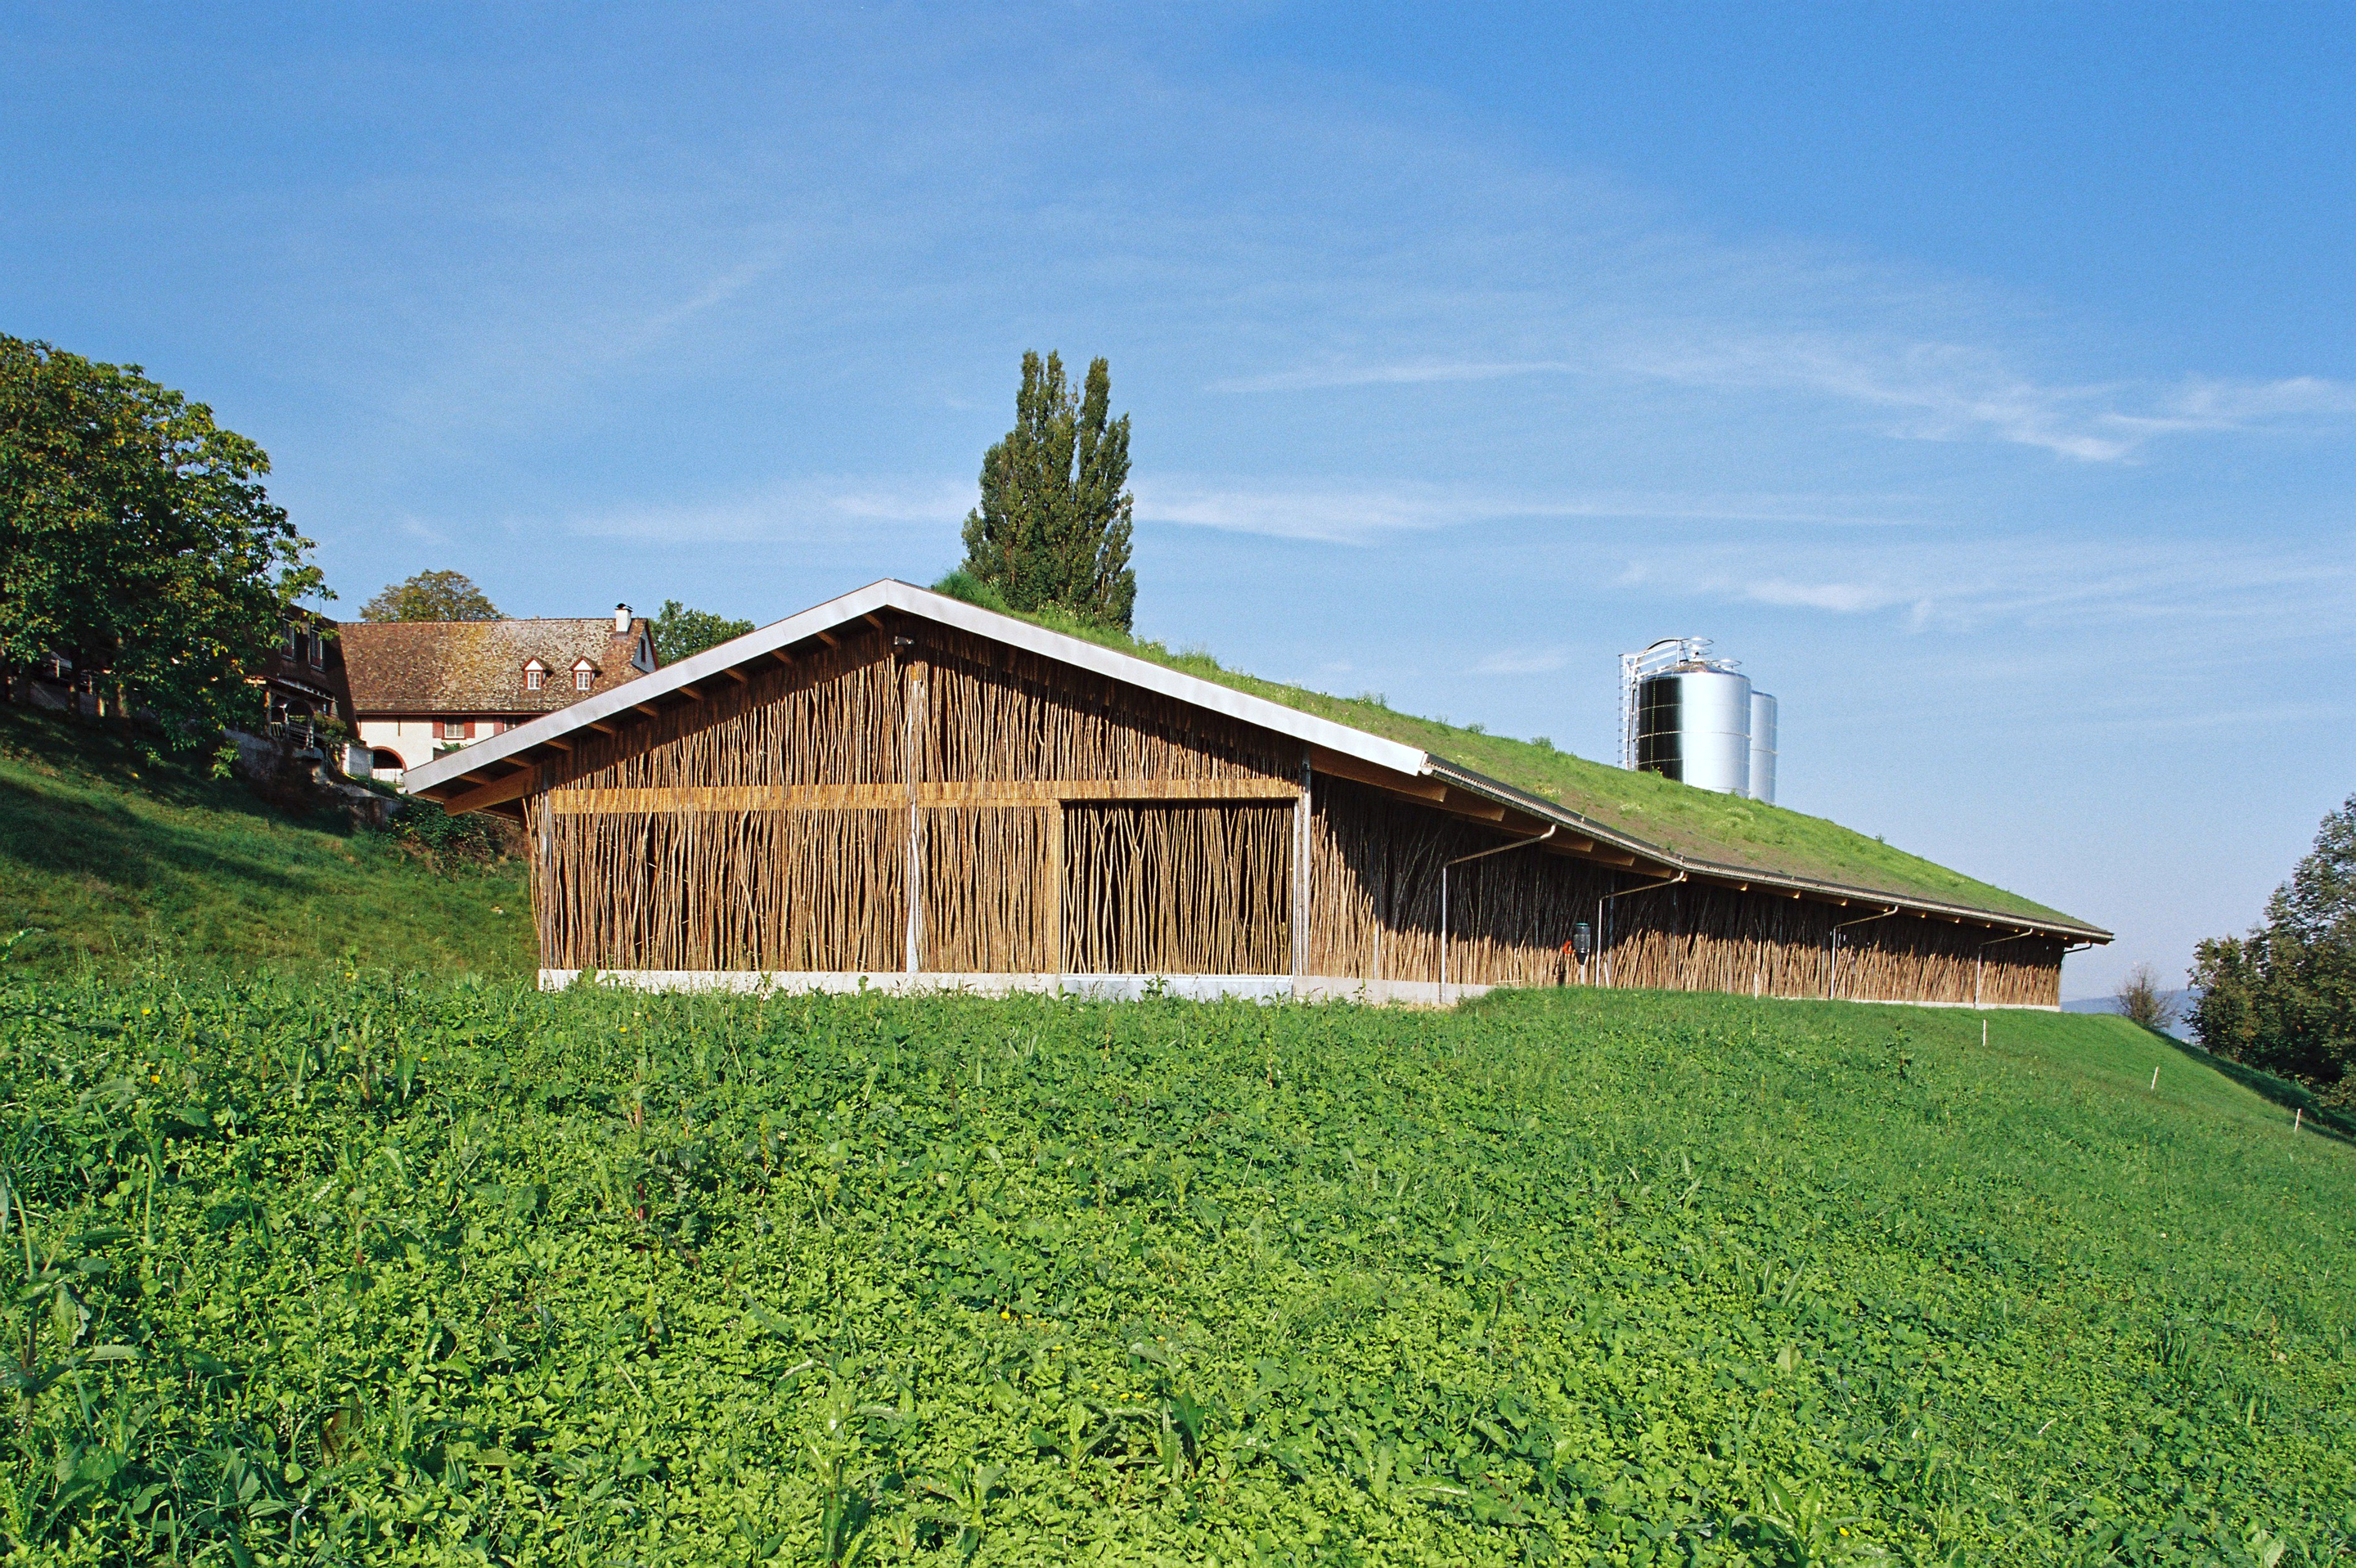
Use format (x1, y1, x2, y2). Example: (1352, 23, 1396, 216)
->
(935, 572, 2085, 925)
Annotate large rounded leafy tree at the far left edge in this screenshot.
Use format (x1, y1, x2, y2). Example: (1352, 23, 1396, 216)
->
(0, 335, 327, 744)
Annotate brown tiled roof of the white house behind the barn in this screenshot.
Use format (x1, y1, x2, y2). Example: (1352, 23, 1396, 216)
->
(342, 614, 653, 716)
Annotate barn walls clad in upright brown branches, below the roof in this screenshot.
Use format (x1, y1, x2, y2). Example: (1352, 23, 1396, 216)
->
(528, 624, 2059, 1005)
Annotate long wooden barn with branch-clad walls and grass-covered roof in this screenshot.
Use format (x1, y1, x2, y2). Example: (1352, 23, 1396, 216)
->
(410, 582, 2109, 1008)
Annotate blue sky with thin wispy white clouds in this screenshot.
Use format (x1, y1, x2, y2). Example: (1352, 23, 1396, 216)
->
(0, 5, 2356, 996)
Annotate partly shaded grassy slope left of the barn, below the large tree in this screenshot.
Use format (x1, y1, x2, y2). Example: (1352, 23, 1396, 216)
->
(0, 707, 535, 975)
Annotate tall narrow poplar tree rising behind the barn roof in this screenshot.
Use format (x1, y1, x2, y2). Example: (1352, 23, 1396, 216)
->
(964, 353, 1138, 631)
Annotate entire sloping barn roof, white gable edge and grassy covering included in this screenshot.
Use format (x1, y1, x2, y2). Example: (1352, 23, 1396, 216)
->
(405, 579, 2111, 941)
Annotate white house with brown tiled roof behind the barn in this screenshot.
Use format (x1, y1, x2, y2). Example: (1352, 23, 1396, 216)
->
(337, 605, 655, 777)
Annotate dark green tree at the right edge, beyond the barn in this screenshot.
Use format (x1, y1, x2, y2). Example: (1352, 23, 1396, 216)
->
(2191, 796, 2356, 1099)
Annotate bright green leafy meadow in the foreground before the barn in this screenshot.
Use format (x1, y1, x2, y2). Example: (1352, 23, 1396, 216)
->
(0, 973, 2356, 1566)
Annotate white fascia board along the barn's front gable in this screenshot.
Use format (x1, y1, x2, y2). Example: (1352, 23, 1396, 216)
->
(402, 579, 1430, 793)
